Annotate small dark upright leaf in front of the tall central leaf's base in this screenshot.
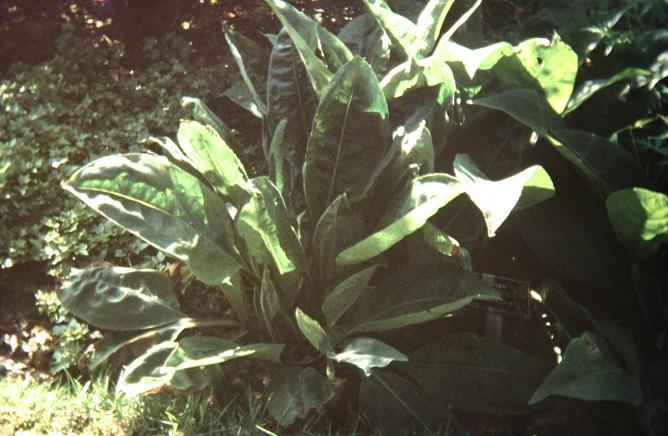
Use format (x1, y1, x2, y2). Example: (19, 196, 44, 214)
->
(312, 193, 366, 283)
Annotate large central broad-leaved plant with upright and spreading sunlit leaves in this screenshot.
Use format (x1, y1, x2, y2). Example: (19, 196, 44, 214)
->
(60, 0, 561, 429)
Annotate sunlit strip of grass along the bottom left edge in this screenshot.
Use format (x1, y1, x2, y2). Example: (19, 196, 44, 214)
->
(0, 376, 370, 435)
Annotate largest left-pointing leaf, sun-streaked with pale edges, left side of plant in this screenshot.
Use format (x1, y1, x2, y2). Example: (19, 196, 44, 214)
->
(63, 153, 240, 285)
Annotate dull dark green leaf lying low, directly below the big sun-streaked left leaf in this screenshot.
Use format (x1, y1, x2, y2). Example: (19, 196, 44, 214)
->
(59, 267, 186, 330)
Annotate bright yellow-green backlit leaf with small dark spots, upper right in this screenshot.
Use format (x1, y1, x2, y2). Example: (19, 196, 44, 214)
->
(494, 34, 578, 113)
